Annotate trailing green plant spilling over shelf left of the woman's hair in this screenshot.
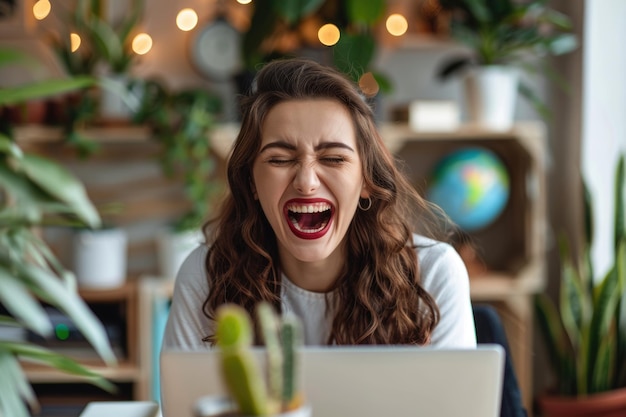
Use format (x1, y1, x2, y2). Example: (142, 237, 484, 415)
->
(134, 80, 222, 231)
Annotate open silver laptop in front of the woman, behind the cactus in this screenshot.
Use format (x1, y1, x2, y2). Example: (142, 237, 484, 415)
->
(160, 345, 505, 417)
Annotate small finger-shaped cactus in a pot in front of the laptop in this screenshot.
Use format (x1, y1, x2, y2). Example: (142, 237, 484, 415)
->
(198, 302, 311, 417)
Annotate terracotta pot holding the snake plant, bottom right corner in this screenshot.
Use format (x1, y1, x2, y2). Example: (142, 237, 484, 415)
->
(539, 388, 626, 417)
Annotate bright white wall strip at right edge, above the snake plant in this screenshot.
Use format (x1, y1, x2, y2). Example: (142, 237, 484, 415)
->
(581, 0, 626, 275)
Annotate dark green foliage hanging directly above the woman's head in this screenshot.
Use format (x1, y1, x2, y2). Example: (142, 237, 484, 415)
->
(241, 0, 391, 91)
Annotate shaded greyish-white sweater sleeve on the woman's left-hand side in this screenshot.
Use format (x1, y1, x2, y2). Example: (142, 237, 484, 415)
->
(162, 246, 211, 350)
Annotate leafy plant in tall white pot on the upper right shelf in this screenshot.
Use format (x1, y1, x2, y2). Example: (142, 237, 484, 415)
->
(438, 0, 577, 128)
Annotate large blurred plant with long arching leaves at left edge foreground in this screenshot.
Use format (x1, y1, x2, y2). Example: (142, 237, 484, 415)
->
(0, 49, 116, 417)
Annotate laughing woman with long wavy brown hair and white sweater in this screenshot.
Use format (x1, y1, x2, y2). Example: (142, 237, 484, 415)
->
(163, 59, 476, 349)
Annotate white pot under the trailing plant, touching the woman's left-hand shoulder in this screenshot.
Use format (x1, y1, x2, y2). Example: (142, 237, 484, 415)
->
(156, 230, 204, 279)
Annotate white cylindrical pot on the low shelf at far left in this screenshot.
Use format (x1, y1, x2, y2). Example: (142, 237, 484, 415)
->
(73, 228, 128, 289)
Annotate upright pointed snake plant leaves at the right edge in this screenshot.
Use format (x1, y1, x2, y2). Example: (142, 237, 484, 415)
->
(536, 155, 626, 396)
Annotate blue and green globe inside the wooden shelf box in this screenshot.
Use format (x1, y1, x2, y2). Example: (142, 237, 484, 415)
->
(426, 147, 510, 232)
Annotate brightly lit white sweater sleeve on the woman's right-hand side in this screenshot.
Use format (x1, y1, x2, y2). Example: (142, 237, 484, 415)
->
(418, 237, 476, 348)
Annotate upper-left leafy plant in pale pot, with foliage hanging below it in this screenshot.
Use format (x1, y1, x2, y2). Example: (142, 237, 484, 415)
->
(47, 0, 144, 156)
